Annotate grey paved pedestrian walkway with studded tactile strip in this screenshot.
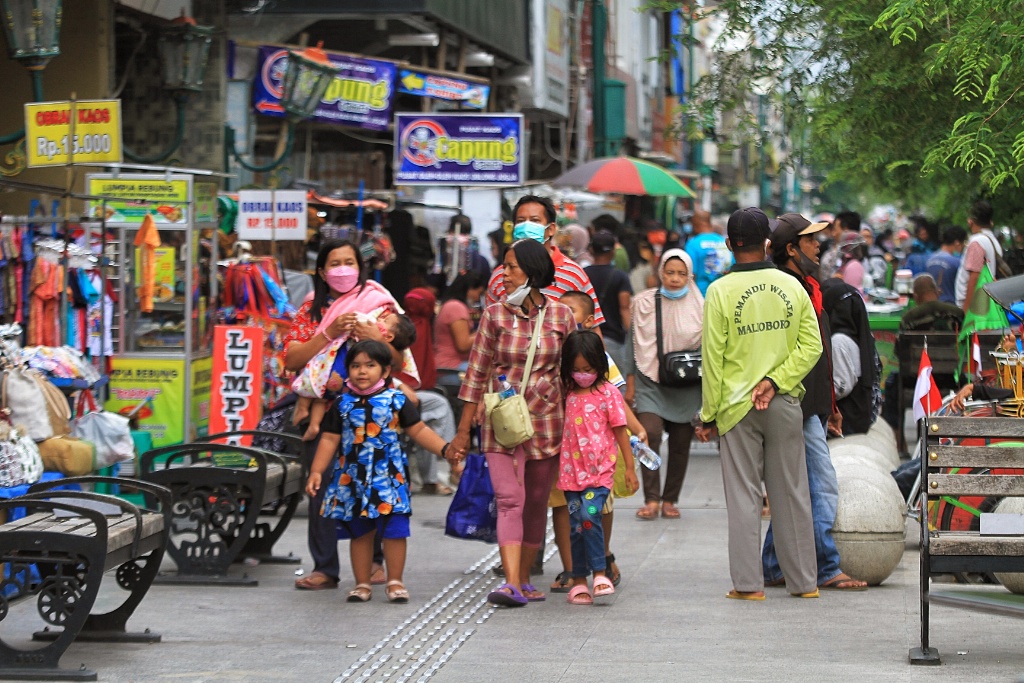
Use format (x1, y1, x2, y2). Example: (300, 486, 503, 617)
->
(19, 450, 1024, 683)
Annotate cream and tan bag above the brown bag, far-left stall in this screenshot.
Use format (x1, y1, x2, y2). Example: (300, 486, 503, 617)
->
(0, 366, 71, 441)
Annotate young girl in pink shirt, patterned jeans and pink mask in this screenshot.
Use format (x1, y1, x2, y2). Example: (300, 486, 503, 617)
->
(558, 330, 640, 605)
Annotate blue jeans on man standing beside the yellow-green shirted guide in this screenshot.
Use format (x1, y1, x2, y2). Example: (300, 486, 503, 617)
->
(761, 416, 842, 586)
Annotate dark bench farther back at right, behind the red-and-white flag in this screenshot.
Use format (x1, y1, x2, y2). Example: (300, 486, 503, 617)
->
(897, 331, 1002, 454)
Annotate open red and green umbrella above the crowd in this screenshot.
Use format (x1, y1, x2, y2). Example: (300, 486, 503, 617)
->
(552, 157, 696, 199)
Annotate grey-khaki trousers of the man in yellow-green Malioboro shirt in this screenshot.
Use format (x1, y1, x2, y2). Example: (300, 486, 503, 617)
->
(721, 394, 817, 593)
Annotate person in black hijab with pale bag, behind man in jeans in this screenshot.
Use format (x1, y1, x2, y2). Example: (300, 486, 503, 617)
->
(821, 278, 882, 436)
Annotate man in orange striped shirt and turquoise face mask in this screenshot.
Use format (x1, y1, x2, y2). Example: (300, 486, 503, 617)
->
(487, 195, 604, 327)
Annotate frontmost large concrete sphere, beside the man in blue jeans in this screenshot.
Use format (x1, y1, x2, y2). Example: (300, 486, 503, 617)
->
(833, 472, 906, 586)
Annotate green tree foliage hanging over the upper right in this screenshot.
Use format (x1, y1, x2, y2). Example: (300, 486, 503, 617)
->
(649, 0, 1024, 221)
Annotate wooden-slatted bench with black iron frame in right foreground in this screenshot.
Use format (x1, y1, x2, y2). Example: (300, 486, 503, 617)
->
(910, 418, 1024, 665)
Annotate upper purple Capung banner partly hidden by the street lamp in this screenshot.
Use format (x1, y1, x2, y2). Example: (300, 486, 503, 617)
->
(253, 46, 397, 130)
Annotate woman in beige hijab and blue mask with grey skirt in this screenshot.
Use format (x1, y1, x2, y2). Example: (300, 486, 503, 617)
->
(622, 249, 703, 520)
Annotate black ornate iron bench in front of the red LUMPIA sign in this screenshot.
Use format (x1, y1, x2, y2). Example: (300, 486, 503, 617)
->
(139, 434, 305, 586)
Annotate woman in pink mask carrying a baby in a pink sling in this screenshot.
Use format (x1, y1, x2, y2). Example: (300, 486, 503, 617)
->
(285, 240, 401, 591)
